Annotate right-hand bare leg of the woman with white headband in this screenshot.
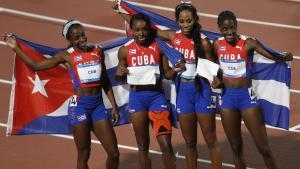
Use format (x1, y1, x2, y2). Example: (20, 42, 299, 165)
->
(93, 119, 119, 169)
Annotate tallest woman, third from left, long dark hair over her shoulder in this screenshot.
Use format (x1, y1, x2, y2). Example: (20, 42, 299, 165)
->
(113, 2, 222, 169)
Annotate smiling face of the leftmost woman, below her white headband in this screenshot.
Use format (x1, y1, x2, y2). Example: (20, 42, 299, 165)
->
(69, 26, 87, 51)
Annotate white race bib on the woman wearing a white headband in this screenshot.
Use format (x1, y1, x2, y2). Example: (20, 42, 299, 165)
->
(77, 61, 101, 83)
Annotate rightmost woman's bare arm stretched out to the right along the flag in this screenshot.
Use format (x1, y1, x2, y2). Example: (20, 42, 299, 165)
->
(245, 38, 293, 62)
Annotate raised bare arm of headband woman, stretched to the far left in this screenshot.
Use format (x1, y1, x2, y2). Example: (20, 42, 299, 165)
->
(4, 34, 68, 71)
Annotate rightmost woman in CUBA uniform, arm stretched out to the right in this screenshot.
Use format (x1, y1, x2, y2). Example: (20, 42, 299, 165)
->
(213, 11, 293, 169)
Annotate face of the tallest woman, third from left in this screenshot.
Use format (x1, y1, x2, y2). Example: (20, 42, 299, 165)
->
(177, 10, 196, 35)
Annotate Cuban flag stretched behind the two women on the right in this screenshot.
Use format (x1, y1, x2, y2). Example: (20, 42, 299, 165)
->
(119, 0, 291, 129)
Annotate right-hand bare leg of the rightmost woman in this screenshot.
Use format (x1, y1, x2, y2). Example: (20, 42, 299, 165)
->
(242, 106, 277, 169)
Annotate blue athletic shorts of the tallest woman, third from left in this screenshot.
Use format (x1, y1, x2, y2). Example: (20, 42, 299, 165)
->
(176, 80, 216, 114)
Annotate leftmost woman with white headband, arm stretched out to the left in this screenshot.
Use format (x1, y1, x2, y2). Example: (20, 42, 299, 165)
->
(4, 20, 119, 169)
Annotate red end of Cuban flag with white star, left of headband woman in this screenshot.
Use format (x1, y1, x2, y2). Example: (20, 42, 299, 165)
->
(7, 38, 73, 135)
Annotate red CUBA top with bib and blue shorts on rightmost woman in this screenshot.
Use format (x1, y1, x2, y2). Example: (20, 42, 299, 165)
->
(218, 36, 258, 111)
